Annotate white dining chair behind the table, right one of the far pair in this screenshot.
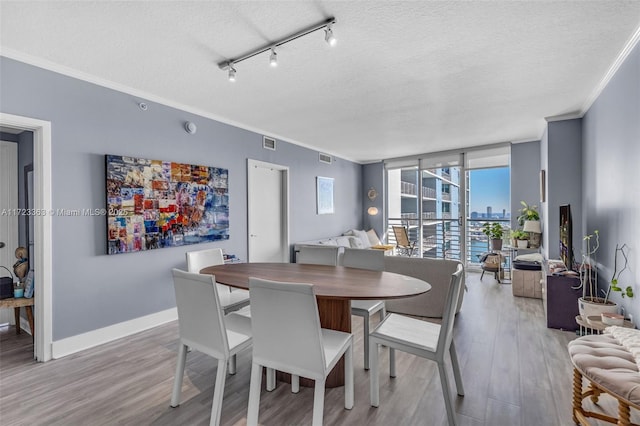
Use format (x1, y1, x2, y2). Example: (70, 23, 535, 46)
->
(342, 248, 387, 370)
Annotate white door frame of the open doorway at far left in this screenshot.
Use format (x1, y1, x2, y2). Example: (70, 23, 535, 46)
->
(0, 112, 53, 362)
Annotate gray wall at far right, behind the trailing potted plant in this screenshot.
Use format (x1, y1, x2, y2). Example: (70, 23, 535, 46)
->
(582, 45, 640, 324)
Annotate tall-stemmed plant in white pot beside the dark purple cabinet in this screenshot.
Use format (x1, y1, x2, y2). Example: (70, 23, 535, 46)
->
(577, 229, 618, 322)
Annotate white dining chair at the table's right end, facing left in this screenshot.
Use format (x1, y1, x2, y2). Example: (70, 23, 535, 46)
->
(369, 265, 464, 426)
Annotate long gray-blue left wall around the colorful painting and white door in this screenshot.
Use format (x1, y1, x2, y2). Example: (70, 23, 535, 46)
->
(0, 58, 363, 341)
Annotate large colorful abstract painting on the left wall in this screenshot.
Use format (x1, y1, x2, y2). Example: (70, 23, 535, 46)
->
(105, 155, 229, 254)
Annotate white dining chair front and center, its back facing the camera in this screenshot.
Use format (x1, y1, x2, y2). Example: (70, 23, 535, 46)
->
(247, 278, 353, 426)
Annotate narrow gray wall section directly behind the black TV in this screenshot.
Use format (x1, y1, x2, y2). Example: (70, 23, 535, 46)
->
(543, 119, 583, 259)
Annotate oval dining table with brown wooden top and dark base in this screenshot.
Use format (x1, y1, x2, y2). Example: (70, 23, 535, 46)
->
(200, 263, 431, 387)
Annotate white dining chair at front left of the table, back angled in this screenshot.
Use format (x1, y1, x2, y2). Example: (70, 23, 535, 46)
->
(171, 269, 251, 425)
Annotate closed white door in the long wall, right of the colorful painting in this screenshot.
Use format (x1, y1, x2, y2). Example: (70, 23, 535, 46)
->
(247, 160, 289, 262)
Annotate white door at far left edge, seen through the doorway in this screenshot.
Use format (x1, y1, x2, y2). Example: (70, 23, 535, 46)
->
(0, 141, 18, 324)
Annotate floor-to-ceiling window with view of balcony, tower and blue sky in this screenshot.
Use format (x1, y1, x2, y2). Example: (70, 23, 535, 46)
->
(385, 144, 511, 265)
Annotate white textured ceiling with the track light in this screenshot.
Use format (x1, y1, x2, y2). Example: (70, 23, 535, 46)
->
(0, 0, 640, 162)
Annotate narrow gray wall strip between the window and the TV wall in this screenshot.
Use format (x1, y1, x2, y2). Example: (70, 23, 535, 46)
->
(511, 141, 542, 233)
